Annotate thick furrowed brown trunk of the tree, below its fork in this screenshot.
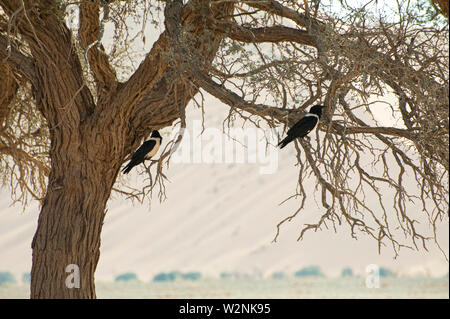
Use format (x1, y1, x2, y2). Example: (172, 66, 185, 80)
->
(31, 126, 121, 298)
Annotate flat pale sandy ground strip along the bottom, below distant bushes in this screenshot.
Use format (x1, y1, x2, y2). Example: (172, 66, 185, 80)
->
(0, 278, 449, 299)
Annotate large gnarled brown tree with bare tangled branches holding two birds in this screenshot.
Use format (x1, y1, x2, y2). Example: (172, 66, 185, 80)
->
(0, 0, 449, 298)
